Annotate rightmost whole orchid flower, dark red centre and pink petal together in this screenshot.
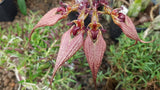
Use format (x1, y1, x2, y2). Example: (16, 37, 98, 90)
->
(109, 8, 153, 45)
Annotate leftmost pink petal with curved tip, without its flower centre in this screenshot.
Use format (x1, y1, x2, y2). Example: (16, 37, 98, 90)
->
(29, 8, 63, 39)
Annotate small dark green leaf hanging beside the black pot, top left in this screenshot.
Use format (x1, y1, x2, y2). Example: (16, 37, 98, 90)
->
(17, 0, 27, 15)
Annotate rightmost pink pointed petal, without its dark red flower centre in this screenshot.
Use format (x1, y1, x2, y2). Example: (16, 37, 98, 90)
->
(118, 16, 153, 43)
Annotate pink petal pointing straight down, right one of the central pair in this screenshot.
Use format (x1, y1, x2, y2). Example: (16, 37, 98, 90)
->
(84, 31, 106, 86)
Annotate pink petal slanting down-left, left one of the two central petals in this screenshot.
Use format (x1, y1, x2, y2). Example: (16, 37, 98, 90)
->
(50, 27, 83, 84)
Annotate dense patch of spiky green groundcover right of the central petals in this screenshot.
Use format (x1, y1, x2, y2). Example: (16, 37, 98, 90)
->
(107, 32, 160, 90)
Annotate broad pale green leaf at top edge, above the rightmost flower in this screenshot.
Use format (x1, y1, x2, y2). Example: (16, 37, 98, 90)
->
(128, 0, 142, 17)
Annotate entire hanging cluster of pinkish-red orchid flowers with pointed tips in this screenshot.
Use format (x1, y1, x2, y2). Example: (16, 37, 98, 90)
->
(29, 0, 152, 86)
